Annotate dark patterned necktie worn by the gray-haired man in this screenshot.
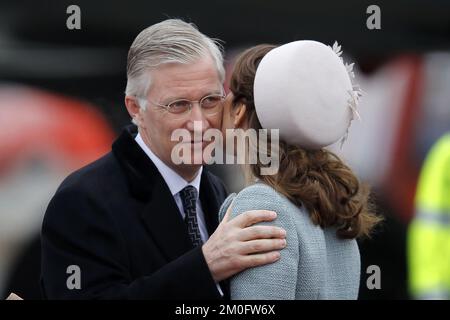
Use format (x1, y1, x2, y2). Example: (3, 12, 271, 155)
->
(180, 186, 203, 247)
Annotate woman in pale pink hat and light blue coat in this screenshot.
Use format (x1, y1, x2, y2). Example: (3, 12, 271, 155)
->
(220, 41, 380, 299)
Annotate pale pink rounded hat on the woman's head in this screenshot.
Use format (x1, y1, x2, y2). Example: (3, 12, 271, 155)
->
(254, 40, 361, 149)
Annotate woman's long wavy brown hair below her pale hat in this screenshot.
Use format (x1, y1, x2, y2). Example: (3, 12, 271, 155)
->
(230, 44, 382, 239)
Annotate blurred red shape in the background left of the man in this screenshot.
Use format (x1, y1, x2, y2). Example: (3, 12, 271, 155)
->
(0, 86, 114, 173)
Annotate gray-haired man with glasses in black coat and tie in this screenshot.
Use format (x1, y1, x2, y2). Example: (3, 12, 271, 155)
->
(41, 19, 285, 299)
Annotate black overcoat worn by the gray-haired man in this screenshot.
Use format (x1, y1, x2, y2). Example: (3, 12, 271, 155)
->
(41, 126, 228, 299)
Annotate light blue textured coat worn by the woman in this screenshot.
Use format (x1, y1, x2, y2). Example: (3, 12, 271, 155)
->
(219, 183, 361, 300)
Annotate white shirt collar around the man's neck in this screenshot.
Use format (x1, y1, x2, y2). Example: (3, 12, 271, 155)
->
(134, 133, 203, 199)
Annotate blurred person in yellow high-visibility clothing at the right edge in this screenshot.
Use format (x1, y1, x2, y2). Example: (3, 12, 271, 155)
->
(408, 133, 450, 299)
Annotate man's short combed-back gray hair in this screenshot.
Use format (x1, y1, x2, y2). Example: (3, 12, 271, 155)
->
(125, 19, 225, 109)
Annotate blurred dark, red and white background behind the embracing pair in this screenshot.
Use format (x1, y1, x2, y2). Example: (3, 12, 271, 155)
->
(0, 0, 450, 299)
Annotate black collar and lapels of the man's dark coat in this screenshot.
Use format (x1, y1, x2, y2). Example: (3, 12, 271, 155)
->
(112, 125, 221, 261)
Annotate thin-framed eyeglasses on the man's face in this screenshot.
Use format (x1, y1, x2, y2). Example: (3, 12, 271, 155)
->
(141, 94, 225, 118)
